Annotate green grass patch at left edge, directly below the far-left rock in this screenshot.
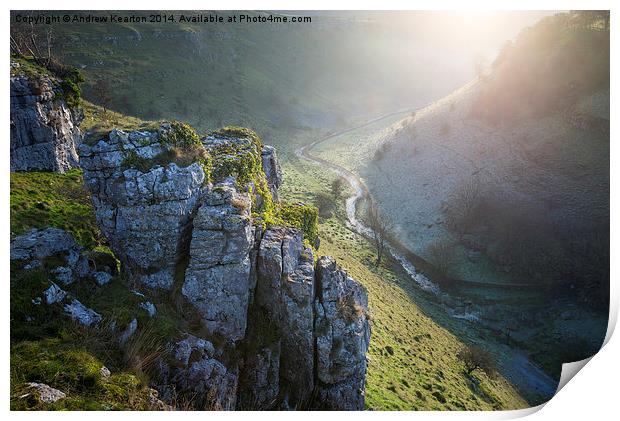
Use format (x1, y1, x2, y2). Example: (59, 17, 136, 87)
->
(11, 170, 104, 248)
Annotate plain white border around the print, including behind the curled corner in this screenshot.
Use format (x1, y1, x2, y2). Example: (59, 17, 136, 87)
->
(0, 0, 620, 421)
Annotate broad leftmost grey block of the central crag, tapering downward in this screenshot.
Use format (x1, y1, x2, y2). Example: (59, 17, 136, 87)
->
(80, 131, 208, 290)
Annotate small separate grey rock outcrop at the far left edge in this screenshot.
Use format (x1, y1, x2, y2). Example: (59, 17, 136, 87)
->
(11, 76, 82, 173)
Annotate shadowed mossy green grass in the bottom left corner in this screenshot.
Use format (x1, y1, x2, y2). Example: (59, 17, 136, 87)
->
(10, 257, 168, 410)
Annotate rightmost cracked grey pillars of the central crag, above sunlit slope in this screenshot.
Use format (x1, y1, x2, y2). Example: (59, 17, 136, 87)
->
(240, 226, 370, 410)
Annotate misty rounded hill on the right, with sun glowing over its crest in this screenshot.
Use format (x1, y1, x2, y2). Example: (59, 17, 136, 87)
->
(359, 13, 609, 306)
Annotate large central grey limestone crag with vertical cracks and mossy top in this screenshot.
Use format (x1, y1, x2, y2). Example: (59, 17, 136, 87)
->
(75, 126, 370, 410)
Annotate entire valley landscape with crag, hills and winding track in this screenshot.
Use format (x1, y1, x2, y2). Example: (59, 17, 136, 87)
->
(10, 11, 610, 410)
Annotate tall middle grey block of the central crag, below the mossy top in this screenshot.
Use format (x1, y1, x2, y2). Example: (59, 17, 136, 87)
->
(182, 184, 254, 341)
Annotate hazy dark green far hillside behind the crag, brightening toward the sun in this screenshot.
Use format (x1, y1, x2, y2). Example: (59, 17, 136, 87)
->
(12, 11, 548, 153)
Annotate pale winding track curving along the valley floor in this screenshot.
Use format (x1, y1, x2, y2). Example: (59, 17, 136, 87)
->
(295, 108, 557, 401)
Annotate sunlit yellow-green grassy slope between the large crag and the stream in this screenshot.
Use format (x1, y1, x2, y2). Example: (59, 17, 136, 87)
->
(281, 157, 527, 410)
